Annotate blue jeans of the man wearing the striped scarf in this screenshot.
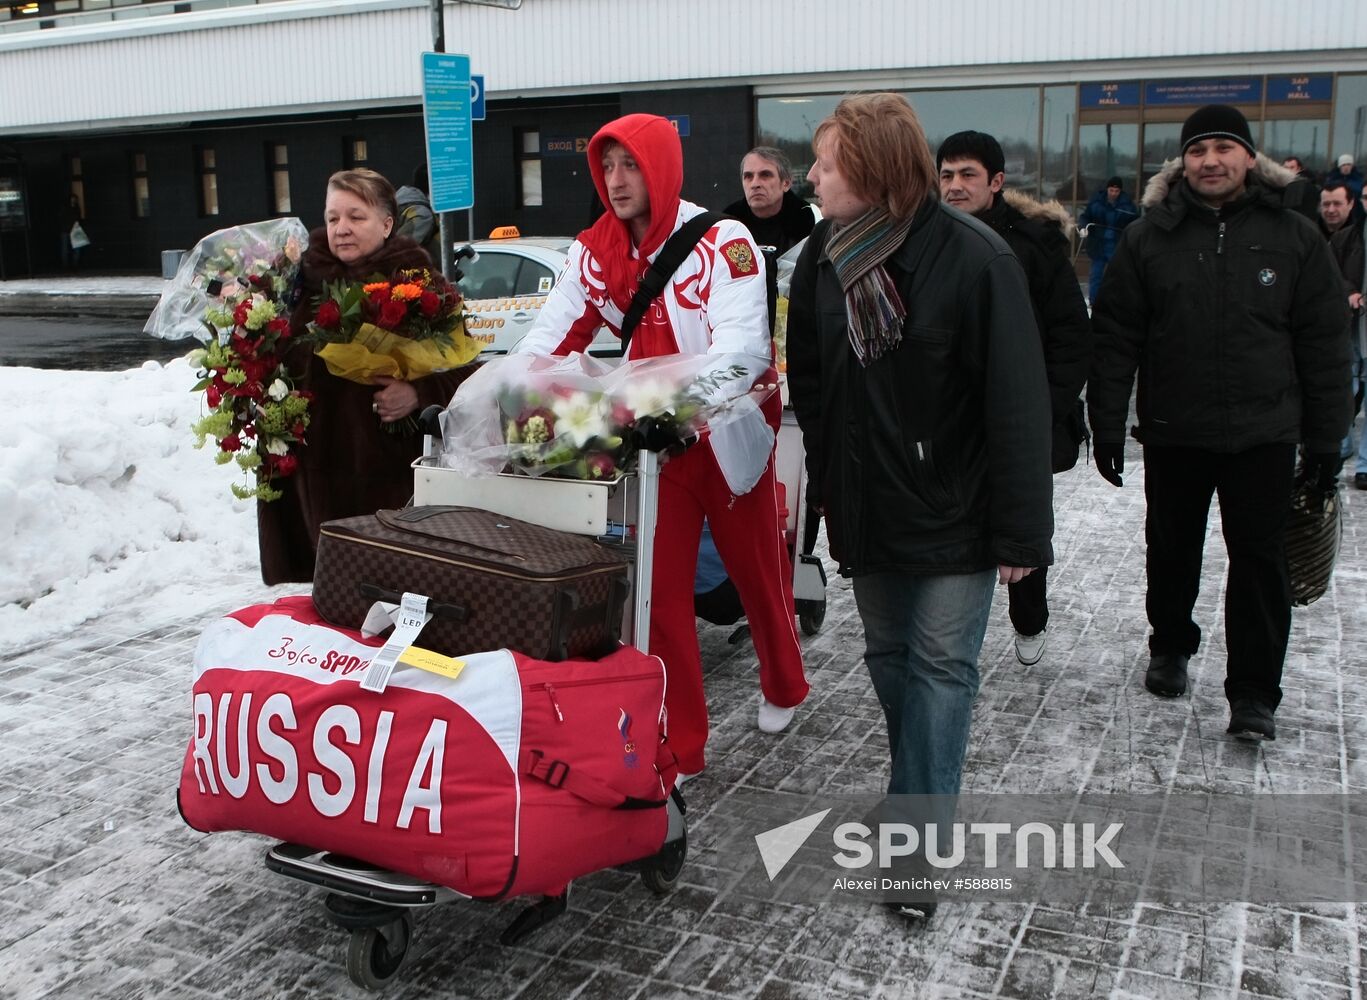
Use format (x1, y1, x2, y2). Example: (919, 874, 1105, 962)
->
(854, 568, 997, 795)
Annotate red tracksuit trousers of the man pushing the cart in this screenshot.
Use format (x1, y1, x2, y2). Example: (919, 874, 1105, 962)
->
(651, 431, 809, 773)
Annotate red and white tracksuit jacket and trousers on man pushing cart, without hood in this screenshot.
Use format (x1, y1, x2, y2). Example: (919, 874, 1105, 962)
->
(515, 201, 808, 773)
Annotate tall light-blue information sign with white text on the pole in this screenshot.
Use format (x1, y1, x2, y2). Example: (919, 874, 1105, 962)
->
(422, 52, 474, 212)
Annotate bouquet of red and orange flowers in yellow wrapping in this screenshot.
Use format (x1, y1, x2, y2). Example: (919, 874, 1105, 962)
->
(309, 268, 481, 429)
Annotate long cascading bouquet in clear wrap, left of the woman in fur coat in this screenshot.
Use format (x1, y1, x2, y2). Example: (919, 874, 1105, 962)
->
(146, 219, 310, 501)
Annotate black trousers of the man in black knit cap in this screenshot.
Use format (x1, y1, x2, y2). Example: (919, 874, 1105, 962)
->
(1144, 444, 1296, 708)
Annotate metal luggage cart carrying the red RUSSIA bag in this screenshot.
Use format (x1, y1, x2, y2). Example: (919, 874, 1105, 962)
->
(265, 434, 688, 989)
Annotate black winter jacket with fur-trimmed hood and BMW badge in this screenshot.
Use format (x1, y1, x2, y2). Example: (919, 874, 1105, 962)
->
(1087, 153, 1351, 454)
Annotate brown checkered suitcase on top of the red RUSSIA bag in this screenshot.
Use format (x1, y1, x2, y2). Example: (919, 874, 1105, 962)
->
(313, 507, 629, 660)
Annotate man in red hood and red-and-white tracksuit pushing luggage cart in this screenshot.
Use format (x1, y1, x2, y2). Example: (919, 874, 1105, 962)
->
(517, 115, 808, 777)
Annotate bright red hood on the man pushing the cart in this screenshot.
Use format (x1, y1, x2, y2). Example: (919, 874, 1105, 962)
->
(580, 115, 684, 310)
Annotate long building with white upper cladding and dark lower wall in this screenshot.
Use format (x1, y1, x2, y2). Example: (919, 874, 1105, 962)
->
(0, 0, 1367, 276)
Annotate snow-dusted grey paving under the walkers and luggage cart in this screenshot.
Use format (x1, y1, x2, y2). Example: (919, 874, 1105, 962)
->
(0, 434, 1367, 1000)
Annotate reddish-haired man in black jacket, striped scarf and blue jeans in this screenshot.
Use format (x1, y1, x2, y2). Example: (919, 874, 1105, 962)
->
(787, 94, 1054, 917)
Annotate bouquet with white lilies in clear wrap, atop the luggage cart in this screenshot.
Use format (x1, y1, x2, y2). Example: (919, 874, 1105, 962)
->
(442, 354, 775, 480)
